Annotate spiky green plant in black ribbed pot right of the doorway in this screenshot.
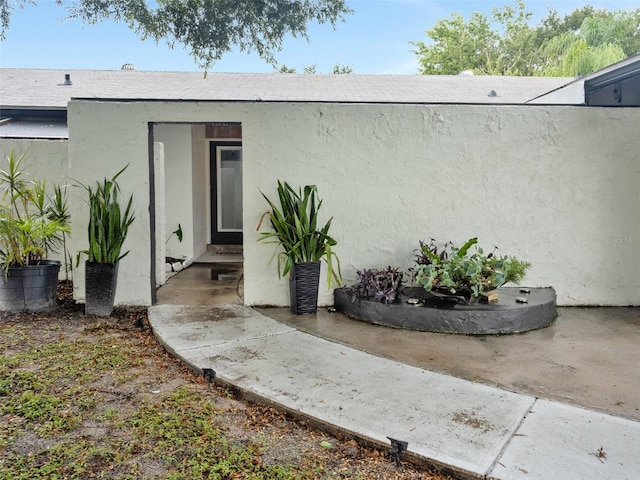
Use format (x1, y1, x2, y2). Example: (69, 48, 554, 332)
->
(258, 180, 341, 314)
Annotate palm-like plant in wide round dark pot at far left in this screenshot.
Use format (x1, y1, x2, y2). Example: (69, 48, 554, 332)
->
(0, 150, 70, 311)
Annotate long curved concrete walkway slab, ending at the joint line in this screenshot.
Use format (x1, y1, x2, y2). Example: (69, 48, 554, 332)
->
(149, 305, 534, 478)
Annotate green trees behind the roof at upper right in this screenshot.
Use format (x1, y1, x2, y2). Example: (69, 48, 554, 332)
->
(412, 0, 640, 76)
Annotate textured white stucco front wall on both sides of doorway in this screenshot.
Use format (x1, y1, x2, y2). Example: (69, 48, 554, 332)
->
(69, 101, 640, 305)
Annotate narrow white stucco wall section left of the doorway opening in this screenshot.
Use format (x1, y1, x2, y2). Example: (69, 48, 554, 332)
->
(68, 101, 155, 305)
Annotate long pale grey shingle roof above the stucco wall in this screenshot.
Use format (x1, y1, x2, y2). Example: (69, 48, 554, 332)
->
(0, 68, 572, 109)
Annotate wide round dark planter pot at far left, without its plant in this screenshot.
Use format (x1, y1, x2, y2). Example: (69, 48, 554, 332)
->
(0, 260, 60, 312)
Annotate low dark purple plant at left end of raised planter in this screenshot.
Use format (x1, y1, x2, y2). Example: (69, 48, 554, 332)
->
(348, 266, 404, 305)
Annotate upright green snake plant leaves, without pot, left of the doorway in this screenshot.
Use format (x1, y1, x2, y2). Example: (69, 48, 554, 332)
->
(82, 166, 135, 264)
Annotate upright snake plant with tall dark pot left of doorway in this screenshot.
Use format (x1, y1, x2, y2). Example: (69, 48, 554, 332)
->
(81, 166, 135, 317)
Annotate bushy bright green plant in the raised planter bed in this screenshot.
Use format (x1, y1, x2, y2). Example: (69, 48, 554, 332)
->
(415, 237, 531, 303)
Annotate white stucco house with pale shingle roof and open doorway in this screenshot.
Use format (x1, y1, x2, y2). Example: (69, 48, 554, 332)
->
(0, 61, 640, 306)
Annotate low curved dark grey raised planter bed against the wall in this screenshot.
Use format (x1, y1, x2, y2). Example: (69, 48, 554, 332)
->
(334, 287, 556, 335)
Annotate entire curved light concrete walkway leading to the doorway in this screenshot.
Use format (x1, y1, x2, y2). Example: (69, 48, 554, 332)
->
(149, 304, 640, 480)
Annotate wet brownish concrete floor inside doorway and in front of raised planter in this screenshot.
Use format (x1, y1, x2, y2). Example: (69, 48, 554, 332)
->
(158, 255, 640, 420)
